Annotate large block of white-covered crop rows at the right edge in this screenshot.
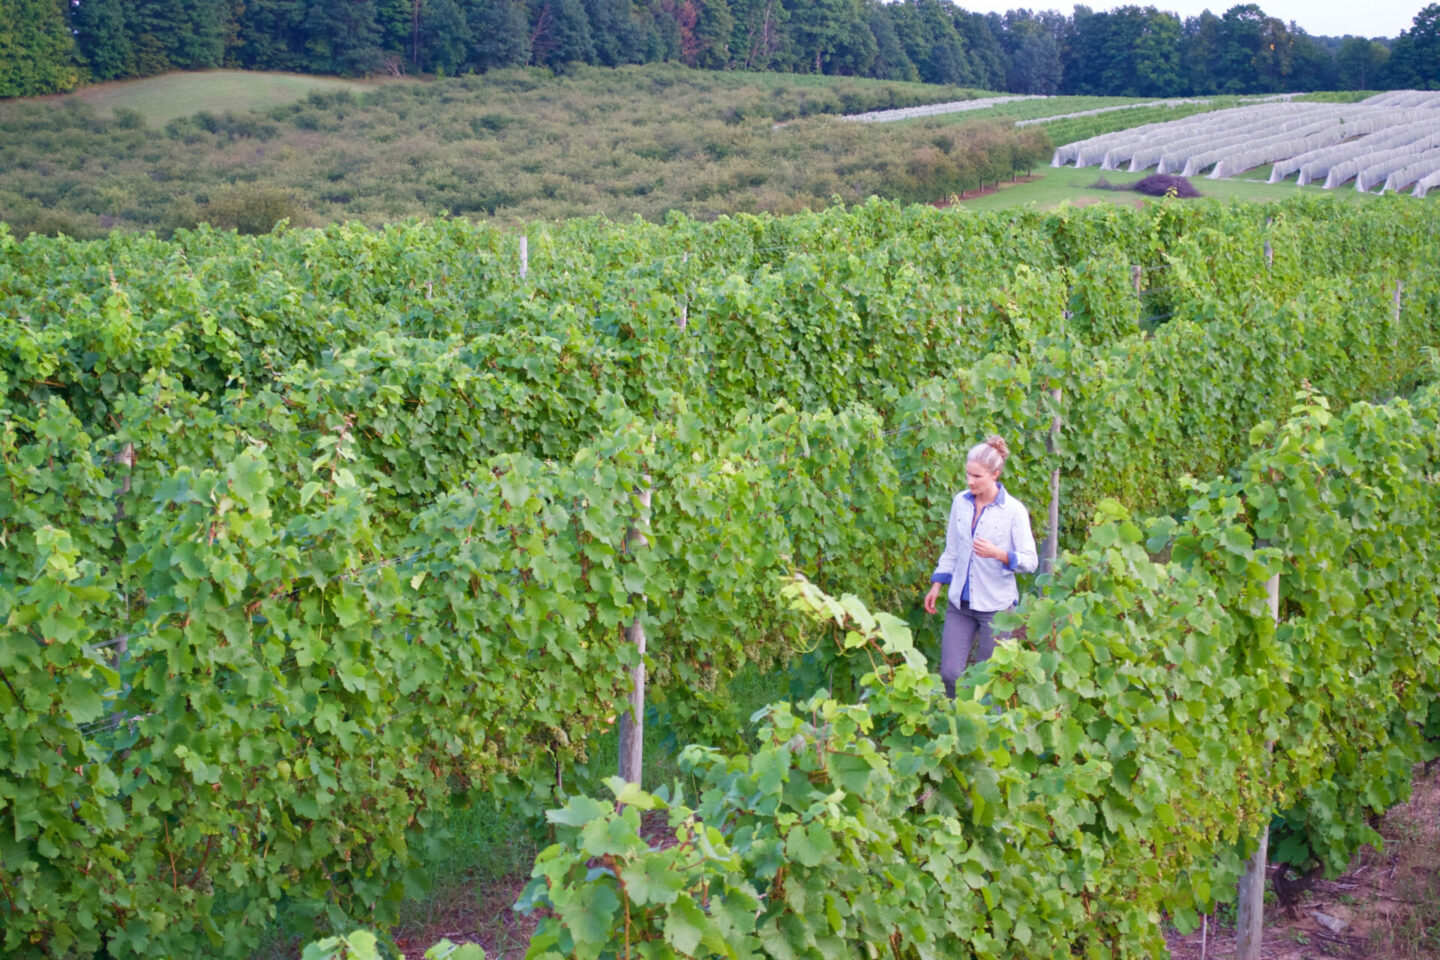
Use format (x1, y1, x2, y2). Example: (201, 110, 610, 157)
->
(1051, 91, 1440, 196)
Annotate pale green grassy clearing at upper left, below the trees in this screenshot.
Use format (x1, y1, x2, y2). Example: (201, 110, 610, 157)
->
(73, 71, 376, 127)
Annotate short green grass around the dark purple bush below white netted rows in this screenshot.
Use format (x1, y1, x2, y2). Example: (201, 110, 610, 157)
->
(963, 167, 1374, 212)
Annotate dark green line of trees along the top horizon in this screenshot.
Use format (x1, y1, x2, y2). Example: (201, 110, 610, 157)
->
(0, 0, 1440, 96)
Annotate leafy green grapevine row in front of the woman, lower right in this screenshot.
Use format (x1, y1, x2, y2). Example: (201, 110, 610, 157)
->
(521, 387, 1440, 960)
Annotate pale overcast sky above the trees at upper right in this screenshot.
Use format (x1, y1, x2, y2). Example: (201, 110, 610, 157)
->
(959, 0, 1433, 37)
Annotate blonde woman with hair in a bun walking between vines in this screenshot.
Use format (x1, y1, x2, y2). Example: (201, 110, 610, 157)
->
(924, 436, 1037, 699)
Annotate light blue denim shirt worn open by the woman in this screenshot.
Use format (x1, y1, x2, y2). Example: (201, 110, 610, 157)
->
(930, 484, 1040, 613)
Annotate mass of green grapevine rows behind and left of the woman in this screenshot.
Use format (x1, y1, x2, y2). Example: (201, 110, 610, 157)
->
(0, 195, 1440, 956)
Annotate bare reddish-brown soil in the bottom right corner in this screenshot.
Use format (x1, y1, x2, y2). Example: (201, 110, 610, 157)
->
(1168, 770, 1440, 960)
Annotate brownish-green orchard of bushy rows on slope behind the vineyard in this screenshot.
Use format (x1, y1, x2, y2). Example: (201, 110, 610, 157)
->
(0, 65, 1051, 236)
